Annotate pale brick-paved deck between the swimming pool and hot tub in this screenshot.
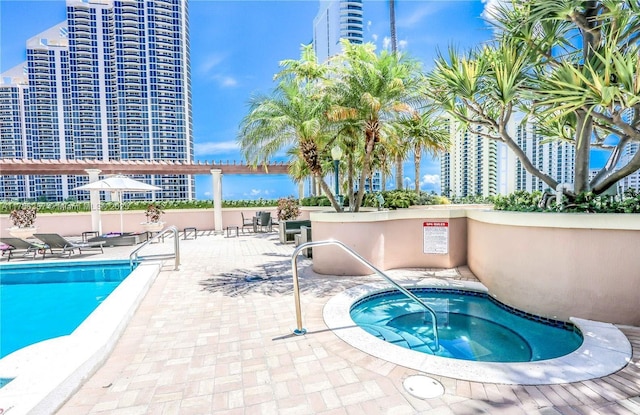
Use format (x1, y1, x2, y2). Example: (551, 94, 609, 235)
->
(58, 233, 640, 415)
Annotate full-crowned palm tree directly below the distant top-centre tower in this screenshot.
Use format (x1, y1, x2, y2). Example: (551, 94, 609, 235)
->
(327, 41, 422, 211)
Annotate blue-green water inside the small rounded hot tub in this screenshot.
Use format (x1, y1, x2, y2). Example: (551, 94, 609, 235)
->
(350, 288, 582, 362)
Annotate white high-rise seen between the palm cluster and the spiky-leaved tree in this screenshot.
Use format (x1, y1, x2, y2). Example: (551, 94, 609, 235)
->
(440, 120, 498, 197)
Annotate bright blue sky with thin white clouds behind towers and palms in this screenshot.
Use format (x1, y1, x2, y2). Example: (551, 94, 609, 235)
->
(0, 0, 491, 199)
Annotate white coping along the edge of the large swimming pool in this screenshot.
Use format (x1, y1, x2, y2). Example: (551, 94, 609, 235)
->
(0, 262, 160, 415)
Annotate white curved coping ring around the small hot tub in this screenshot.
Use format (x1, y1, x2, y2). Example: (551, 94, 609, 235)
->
(323, 278, 632, 385)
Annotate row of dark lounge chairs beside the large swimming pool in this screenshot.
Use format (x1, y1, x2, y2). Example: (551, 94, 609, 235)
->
(0, 233, 105, 261)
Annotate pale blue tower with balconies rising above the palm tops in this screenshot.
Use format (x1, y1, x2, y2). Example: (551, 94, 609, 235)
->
(313, 0, 363, 62)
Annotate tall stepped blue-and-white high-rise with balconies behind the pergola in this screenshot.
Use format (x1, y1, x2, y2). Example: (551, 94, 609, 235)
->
(0, 0, 195, 201)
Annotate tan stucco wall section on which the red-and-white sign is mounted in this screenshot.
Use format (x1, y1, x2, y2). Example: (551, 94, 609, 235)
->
(311, 209, 467, 275)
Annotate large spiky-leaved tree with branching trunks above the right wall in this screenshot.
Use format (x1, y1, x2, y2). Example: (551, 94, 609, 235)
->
(428, 0, 640, 199)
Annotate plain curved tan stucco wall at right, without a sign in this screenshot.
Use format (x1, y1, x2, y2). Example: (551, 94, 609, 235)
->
(468, 212, 640, 326)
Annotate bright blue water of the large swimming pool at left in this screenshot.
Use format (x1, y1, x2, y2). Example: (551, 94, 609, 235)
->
(0, 261, 131, 358)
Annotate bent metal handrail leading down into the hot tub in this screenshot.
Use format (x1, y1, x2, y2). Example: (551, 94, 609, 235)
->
(291, 239, 440, 350)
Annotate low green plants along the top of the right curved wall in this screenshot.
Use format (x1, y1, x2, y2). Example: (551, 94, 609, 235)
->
(493, 189, 640, 213)
